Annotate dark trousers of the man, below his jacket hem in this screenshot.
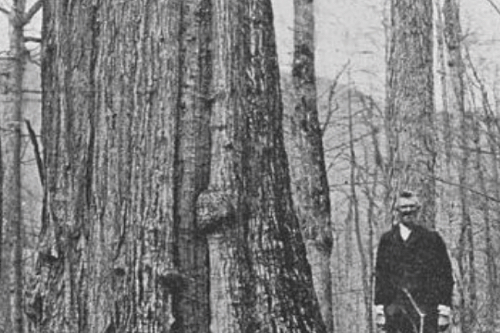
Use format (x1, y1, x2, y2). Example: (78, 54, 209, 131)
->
(385, 302, 438, 333)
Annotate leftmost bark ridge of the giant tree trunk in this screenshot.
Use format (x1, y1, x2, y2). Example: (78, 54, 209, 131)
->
(37, 1, 104, 332)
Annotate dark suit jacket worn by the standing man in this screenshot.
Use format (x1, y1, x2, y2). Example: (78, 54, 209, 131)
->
(375, 226, 453, 308)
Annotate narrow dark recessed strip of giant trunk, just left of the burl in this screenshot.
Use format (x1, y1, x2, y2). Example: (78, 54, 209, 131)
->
(174, 0, 212, 333)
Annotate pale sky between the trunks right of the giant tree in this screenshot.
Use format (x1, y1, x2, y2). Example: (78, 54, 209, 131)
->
(273, 0, 500, 96)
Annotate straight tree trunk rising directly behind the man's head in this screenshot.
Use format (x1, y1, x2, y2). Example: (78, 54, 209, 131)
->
(386, 0, 436, 227)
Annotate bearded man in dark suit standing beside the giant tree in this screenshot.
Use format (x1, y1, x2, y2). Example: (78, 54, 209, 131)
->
(375, 191, 453, 333)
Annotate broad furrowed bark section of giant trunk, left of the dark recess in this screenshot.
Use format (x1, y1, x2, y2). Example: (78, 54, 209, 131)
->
(95, 0, 180, 332)
